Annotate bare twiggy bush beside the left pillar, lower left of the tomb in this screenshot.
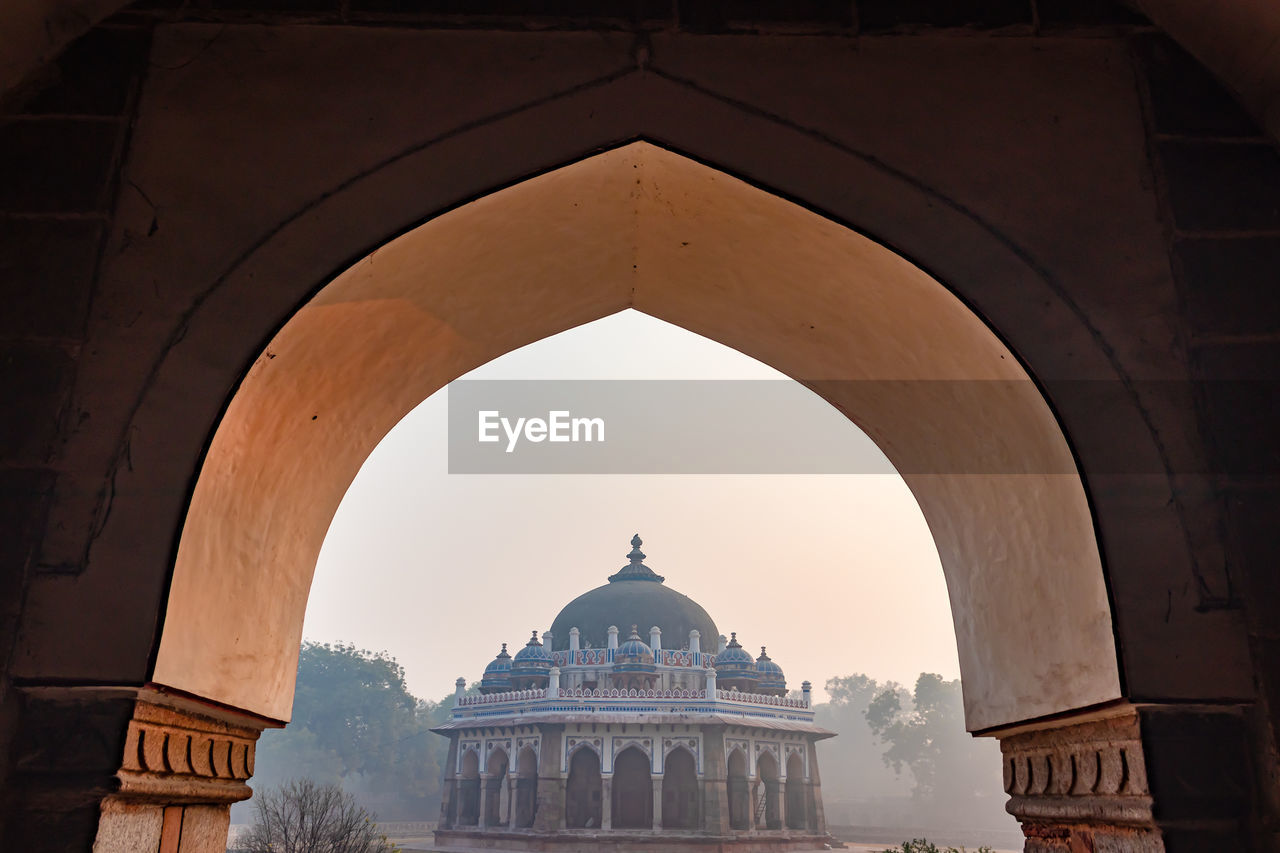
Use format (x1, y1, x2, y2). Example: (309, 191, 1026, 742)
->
(239, 779, 396, 853)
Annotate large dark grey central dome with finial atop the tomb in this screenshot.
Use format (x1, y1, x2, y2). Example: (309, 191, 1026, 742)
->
(552, 535, 719, 653)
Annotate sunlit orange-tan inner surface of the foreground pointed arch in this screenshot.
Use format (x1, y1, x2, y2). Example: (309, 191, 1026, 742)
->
(154, 143, 1120, 730)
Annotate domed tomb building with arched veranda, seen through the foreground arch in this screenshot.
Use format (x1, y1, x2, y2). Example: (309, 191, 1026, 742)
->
(433, 535, 833, 852)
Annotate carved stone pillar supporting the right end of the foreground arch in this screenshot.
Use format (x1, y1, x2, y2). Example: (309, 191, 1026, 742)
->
(1000, 704, 1252, 853)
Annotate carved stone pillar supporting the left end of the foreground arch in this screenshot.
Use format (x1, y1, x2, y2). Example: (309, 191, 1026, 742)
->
(22, 686, 266, 853)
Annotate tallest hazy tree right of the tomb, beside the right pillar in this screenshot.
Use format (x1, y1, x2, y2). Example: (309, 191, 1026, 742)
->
(867, 672, 1009, 824)
